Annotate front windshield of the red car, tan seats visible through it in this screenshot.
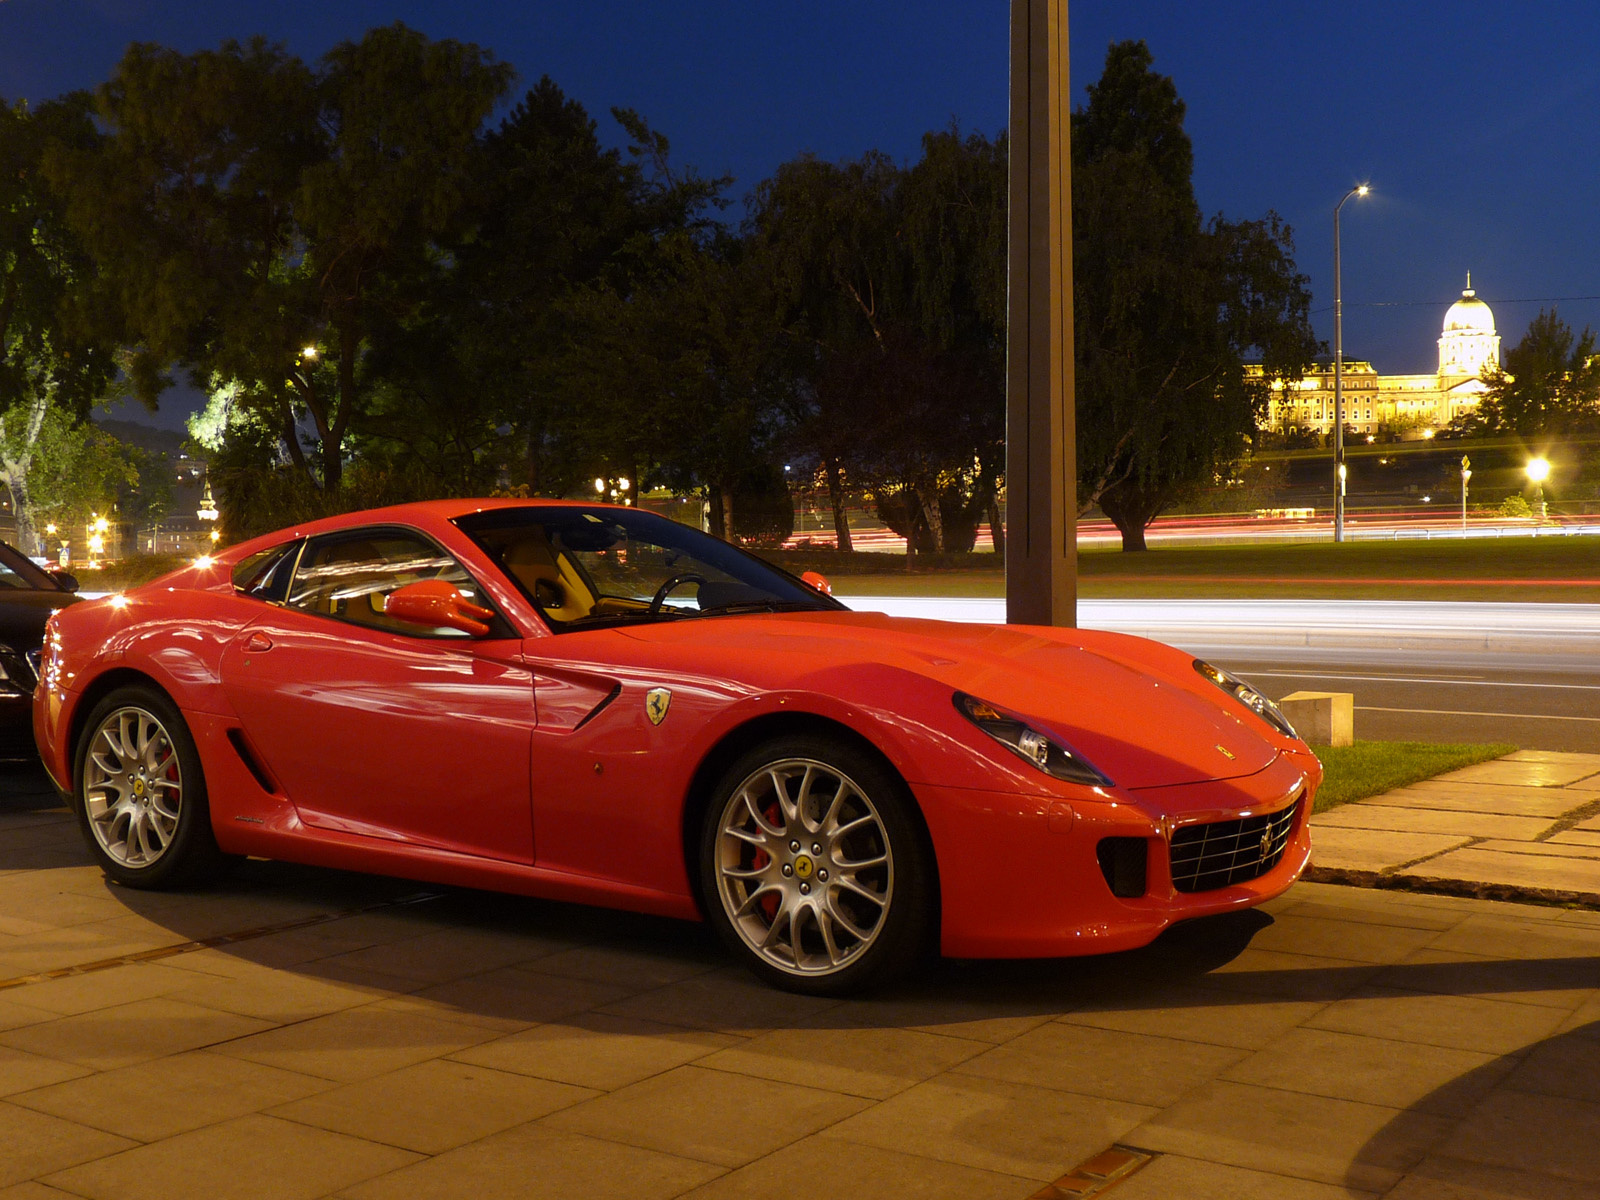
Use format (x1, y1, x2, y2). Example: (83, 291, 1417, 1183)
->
(456, 504, 843, 632)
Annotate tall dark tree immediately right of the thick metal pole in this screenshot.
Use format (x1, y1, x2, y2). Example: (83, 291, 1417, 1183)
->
(1072, 42, 1317, 550)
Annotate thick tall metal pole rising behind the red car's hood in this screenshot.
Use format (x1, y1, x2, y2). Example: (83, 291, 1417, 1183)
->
(1005, 0, 1078, 626)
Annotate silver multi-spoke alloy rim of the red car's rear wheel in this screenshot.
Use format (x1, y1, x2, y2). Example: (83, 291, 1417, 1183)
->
(83, 707, 184, 867)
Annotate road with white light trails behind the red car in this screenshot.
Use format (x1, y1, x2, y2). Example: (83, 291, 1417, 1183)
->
(840, 595, 1600, 752)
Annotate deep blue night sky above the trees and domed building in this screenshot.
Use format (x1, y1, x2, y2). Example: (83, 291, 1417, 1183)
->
(0, 0, 1600, 432)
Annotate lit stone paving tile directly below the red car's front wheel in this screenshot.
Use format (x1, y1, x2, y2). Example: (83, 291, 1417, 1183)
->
(701, 1026, 985, 1099)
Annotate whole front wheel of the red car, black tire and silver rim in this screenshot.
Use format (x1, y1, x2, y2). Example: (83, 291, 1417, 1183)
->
(699, 734, 938, 995)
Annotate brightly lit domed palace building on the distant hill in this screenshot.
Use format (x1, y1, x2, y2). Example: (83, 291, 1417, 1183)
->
(1246, 272, 1499, 438)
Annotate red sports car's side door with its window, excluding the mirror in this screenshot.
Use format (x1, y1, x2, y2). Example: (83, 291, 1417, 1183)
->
(222, 526, 536, 862)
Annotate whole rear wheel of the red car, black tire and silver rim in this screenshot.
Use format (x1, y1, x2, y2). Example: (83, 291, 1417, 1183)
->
(72, 685, 237, 890)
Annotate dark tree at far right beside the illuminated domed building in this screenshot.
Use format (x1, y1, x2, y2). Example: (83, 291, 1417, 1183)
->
(1462, 309, 1600, 437)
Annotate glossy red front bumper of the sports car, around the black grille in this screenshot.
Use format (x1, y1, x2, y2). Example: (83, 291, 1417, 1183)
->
(914, 754, 1320, 958)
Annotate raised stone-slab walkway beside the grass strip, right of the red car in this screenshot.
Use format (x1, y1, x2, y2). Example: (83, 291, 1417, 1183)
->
(1310, 750, 1600, 906)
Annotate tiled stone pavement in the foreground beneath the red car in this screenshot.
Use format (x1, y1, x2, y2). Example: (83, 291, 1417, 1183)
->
(0, 768, 1600, 1200)
